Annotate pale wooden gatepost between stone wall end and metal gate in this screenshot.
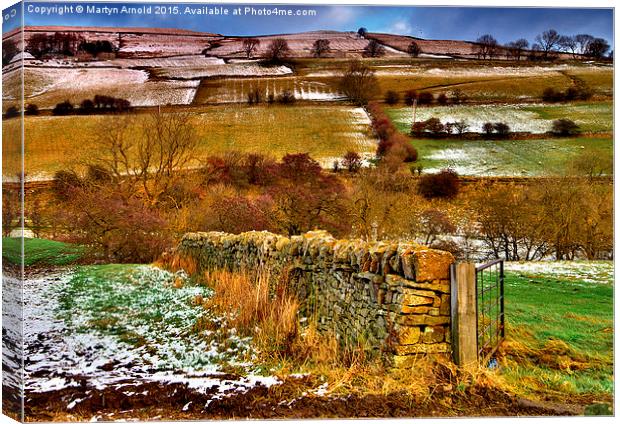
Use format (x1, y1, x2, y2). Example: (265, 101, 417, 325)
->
(451, 262, 478, 367)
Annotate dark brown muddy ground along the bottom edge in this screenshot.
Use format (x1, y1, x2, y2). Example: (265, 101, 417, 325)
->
(17, 378, 588, 421)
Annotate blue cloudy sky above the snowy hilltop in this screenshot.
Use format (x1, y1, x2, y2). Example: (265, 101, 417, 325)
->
(3, 1, 613, 45)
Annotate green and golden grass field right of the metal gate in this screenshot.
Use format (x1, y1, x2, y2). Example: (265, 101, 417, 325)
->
(499, 262, 614, 396)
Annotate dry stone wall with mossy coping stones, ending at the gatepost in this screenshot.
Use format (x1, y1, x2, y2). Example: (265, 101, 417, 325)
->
(176, 231, 454, 366)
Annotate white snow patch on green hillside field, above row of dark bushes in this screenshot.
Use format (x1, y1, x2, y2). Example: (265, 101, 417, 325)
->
(395, 103, 553, 134)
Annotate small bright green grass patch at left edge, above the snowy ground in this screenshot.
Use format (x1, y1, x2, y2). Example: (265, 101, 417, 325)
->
(2, 237, 83, 266)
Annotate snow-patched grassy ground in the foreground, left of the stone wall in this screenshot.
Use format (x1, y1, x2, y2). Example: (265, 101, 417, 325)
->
(3, 266, 278, 410)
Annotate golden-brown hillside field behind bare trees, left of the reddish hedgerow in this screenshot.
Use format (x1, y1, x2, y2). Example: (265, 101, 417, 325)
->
(2, 105, 375, 176)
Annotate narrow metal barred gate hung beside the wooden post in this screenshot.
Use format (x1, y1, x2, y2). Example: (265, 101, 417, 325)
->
(476, 259, 505, 364)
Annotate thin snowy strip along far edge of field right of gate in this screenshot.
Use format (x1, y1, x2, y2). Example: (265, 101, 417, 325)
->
(505, 261, 614, 284)
